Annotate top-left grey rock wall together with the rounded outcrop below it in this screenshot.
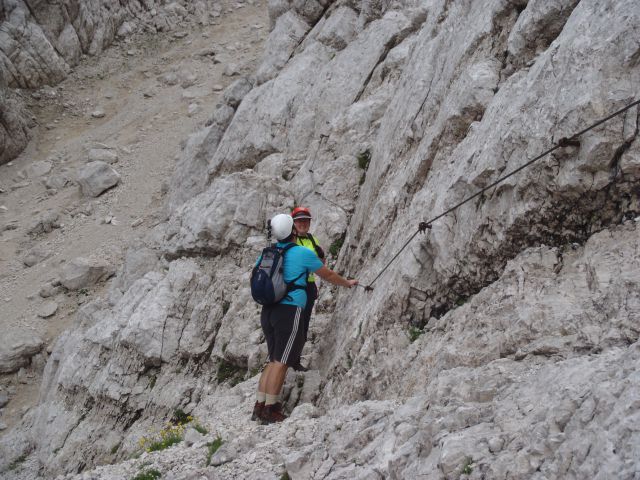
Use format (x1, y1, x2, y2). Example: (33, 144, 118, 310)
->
(0, 0, 217, 164)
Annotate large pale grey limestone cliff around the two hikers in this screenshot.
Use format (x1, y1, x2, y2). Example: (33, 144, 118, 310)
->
(0, 0, 640, 480)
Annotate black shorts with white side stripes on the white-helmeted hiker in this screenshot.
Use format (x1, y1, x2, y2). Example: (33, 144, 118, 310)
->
(260, 303, 304, 366)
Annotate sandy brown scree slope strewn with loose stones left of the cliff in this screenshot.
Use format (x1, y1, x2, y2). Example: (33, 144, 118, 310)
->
(0, 0, 269, 436)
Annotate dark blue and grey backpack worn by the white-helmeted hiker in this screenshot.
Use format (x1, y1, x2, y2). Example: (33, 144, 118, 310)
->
(251, 243, 306, 305)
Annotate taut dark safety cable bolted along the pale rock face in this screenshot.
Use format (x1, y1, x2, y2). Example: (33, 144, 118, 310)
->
(358, 100, 640, 292)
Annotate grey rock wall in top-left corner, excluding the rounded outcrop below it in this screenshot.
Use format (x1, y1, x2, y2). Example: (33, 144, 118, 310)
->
(0, 0, 202, 88)
